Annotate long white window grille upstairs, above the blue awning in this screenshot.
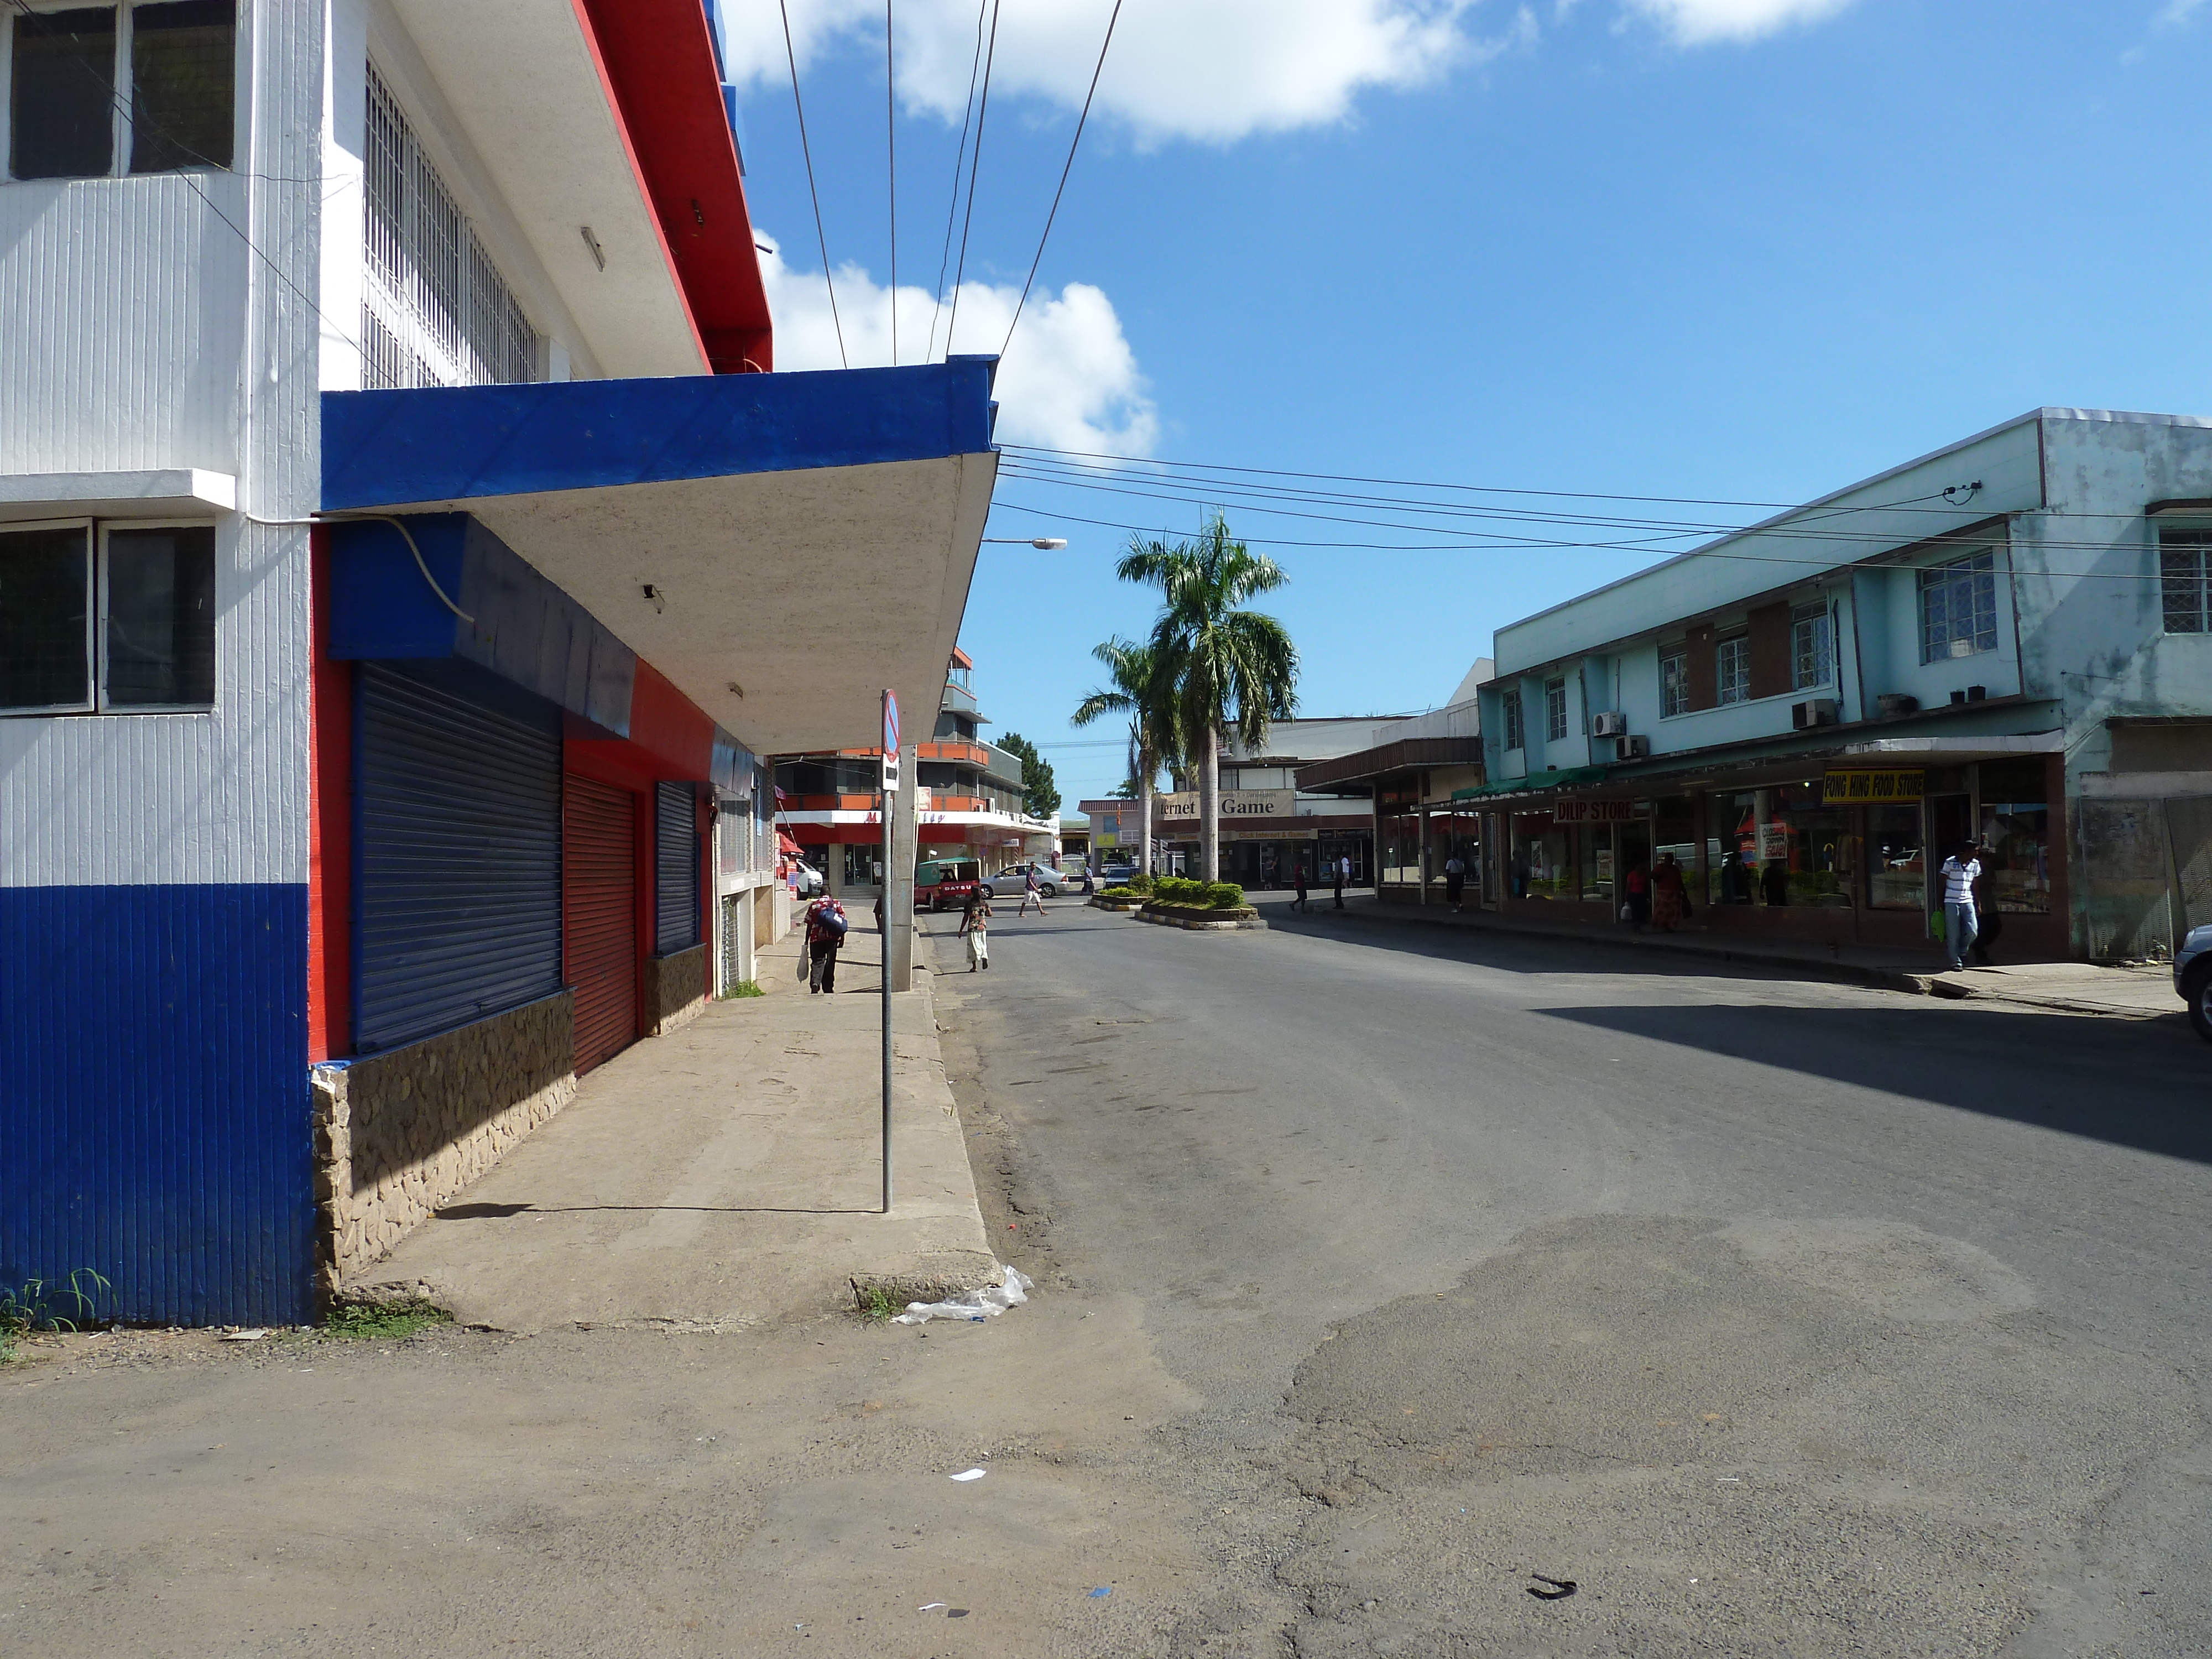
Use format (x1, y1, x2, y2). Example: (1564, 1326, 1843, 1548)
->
(361, 69, 538, 392)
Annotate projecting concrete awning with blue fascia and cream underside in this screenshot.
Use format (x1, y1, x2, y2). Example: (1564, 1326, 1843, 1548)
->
(323, 358, 998, 754)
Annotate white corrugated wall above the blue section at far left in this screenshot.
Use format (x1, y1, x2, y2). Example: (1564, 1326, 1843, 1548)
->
(0, 0, 323, 887)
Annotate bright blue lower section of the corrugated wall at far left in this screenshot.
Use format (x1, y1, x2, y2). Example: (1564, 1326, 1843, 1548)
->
(0, 885, 314, 1325)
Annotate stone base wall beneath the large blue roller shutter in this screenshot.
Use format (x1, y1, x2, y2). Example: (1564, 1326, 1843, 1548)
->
(314, 991, 575, 1305)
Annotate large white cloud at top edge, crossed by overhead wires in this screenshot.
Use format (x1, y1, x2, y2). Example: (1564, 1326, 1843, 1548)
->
(723, 0, 1486, 144)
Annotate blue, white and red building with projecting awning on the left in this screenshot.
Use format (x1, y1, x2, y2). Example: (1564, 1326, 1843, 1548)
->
(0, 0, 995, 1323)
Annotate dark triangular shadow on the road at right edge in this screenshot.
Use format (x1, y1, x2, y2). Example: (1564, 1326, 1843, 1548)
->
(1535, 998, 2212, 1164)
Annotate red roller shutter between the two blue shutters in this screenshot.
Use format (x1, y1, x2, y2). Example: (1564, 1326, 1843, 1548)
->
(562, 772, 637, 1073)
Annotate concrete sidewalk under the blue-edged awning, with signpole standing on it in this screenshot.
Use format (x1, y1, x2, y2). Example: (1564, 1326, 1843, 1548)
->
(347, 922, 995, 1332)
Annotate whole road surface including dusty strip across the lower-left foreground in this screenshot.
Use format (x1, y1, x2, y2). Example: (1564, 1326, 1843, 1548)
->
(0, 902, 2212, 1659)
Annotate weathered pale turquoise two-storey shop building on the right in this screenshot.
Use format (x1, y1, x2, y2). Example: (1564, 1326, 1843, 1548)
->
(1453, 409, 2212, 960)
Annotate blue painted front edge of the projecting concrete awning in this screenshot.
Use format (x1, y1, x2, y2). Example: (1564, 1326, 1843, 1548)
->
(323, 358, 995, 513)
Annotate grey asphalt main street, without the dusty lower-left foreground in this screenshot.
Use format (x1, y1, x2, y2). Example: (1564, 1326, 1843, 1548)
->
(925, 905, 2212, 1655)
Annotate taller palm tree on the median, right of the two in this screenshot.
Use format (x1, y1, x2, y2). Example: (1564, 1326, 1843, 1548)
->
(1115, 513, 1298, 880)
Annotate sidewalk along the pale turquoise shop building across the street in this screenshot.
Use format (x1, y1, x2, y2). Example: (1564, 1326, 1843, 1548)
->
(1248, 891, 2188, 1020)
